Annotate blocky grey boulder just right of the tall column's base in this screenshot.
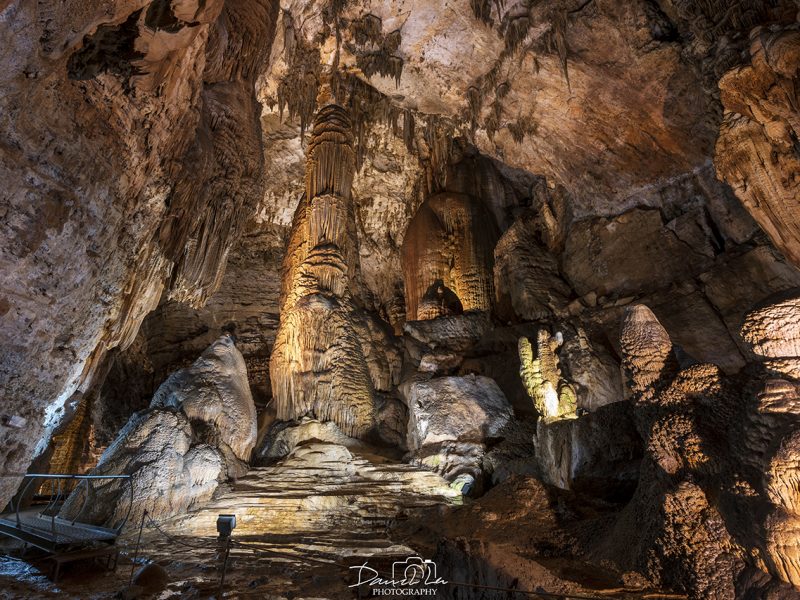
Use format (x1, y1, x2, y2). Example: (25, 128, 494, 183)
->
(400, 376, 513, 451)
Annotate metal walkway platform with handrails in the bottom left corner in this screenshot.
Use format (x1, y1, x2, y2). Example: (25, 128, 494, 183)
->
(0, 474, 133, 554)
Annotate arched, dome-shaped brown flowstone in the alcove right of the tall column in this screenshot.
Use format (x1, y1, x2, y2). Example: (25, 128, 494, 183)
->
(402, 192, 497, 321)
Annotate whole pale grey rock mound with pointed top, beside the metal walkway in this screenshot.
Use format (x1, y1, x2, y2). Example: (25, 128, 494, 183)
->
(61, 336, 256, 526)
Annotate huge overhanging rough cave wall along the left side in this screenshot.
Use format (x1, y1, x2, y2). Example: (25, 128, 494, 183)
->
(0, 0, 278, 503)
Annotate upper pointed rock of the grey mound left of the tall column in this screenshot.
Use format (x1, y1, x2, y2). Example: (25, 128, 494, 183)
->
(151, 336, 256, 462)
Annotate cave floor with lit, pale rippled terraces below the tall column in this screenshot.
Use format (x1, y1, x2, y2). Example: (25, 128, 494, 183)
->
(0, 443, 679, 599)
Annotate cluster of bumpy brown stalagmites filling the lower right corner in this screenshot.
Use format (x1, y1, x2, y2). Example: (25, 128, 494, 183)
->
(605, 299, 800, 598)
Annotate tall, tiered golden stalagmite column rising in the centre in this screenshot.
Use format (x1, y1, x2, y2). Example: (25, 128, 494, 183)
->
(270, 105, 399, 437)
